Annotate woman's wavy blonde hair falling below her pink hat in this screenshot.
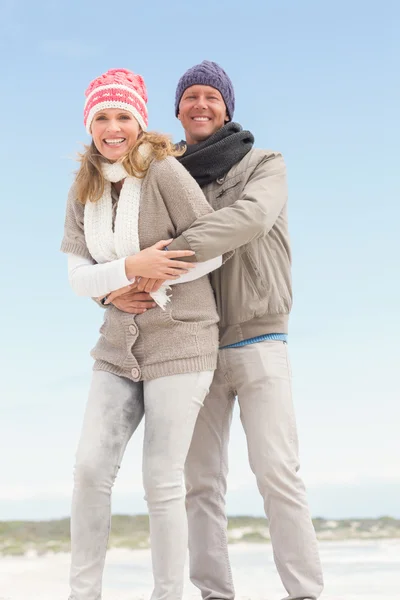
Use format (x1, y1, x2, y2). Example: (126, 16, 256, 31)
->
(75, 132, 185, 204)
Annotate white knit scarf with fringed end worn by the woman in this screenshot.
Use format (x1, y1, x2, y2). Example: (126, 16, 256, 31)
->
(85, 163, 170, 309)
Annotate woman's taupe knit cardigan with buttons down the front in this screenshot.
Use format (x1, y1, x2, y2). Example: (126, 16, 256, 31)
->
(61, 157, 218, 381)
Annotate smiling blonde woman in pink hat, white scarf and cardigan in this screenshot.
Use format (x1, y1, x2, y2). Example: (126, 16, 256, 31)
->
(61, 69, 221, 600)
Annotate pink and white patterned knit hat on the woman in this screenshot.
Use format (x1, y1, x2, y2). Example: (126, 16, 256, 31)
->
(83, 69, 148, 134)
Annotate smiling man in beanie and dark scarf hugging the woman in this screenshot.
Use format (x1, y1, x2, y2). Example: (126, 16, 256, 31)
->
(111, 61, 323, 600)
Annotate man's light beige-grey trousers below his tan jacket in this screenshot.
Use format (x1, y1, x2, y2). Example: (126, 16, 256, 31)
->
(185, 341, 323, 600)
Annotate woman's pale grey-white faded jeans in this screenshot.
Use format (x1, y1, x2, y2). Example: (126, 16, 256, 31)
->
(70, 371, 213, 600)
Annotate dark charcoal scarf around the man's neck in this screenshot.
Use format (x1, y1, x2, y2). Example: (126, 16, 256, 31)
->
(178, 123, 254, 187)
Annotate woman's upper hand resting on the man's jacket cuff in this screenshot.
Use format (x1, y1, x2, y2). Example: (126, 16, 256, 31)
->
(125, 238, 194, 281)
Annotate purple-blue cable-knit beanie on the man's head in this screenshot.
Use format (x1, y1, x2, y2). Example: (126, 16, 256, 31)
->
(175, 60, 235, 121)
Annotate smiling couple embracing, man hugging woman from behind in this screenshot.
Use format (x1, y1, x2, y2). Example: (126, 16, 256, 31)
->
(62, 61, 323, 600)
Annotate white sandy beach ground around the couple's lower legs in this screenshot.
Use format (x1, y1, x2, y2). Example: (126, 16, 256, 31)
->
(0, 539, 400, 600)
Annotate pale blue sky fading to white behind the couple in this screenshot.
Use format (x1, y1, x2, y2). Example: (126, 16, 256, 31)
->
(0, 0, 400, 519)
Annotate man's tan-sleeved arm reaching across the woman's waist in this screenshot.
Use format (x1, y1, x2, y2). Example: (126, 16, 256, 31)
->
(168, 153, 287, 262)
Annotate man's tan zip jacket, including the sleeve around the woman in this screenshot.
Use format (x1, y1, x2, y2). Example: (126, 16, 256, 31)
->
(169, 149, 292, 346)
